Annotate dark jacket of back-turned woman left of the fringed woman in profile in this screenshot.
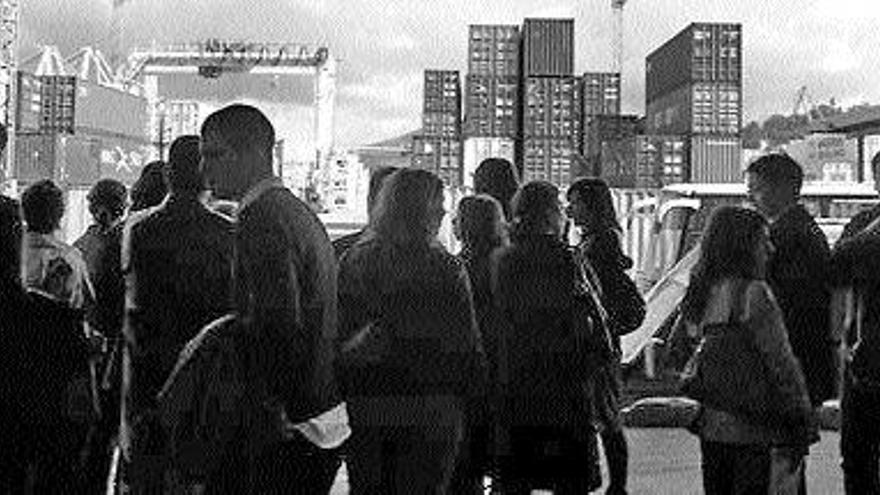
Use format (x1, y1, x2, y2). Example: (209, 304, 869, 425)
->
(492, 236, 592, 435)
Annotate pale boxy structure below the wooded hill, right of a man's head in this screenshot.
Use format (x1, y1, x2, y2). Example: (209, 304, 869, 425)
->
(785, 133, 858, 182)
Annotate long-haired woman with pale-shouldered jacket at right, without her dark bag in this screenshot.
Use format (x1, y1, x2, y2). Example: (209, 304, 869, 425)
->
(682, 206, 818, 495)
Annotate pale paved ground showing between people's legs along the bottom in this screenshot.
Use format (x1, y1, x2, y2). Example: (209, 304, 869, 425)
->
(333, 428, 843, 495)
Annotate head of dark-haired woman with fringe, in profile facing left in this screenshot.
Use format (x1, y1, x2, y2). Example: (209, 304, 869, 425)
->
(566, 178, 620, 232)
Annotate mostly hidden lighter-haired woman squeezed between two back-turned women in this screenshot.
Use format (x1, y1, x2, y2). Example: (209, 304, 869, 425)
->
(451, 194, 509, 495)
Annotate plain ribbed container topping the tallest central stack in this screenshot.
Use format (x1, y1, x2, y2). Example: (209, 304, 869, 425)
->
(521, 19, 574, 77)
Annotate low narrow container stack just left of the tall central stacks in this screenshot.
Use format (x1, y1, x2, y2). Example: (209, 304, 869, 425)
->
(412, 70, 462, 187)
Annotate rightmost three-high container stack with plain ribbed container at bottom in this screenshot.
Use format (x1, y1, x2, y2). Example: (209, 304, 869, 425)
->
(645, 23, 742, 182)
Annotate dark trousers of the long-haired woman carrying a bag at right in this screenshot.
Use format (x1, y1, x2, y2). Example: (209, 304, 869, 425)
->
(700, 441, 771, 495)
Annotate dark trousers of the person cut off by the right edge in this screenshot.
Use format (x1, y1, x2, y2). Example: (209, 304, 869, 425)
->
(840, 370, 880, 495)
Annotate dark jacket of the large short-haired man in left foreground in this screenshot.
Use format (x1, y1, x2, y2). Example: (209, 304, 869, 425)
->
(236, 179, 339, 423)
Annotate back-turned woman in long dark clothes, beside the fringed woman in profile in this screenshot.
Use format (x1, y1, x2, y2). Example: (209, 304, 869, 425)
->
(492, 182, 604, 494)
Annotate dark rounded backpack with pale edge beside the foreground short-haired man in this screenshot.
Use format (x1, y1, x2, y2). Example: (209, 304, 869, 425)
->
(157, 315, 284, 481)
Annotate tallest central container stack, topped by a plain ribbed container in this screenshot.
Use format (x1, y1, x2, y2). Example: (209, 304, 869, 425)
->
(516, 19, 582, 187)
